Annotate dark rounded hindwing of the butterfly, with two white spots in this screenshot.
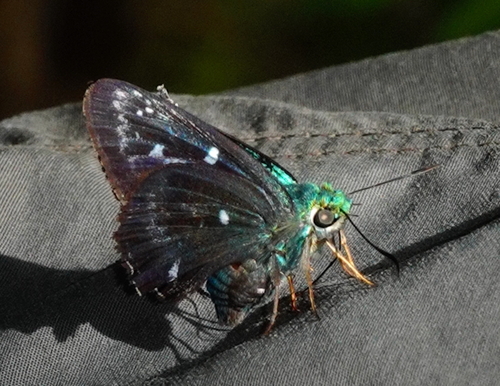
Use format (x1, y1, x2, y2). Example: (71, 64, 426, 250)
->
(115, 162, 280, 296)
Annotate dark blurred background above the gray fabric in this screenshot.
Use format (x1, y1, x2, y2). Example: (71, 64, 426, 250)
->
(0, 0, 500, 119)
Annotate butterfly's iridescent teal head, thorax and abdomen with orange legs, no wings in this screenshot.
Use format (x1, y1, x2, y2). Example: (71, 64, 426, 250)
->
(207, 180, 370, 330)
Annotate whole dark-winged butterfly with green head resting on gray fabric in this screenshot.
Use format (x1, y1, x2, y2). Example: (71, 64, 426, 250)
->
(83, 79, 380, 331)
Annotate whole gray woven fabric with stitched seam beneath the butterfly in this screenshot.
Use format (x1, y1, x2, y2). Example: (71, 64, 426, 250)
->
(0, 29, 500, 385)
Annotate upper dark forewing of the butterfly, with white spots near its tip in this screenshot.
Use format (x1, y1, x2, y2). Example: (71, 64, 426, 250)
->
(84, 79, 289, 206)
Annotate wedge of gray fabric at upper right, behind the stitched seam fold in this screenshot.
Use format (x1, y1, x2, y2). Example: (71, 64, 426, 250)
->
(226, 32, 500, 122)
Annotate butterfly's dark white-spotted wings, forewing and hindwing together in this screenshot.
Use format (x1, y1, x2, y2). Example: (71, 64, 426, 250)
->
(84, 79, 300, 304)
